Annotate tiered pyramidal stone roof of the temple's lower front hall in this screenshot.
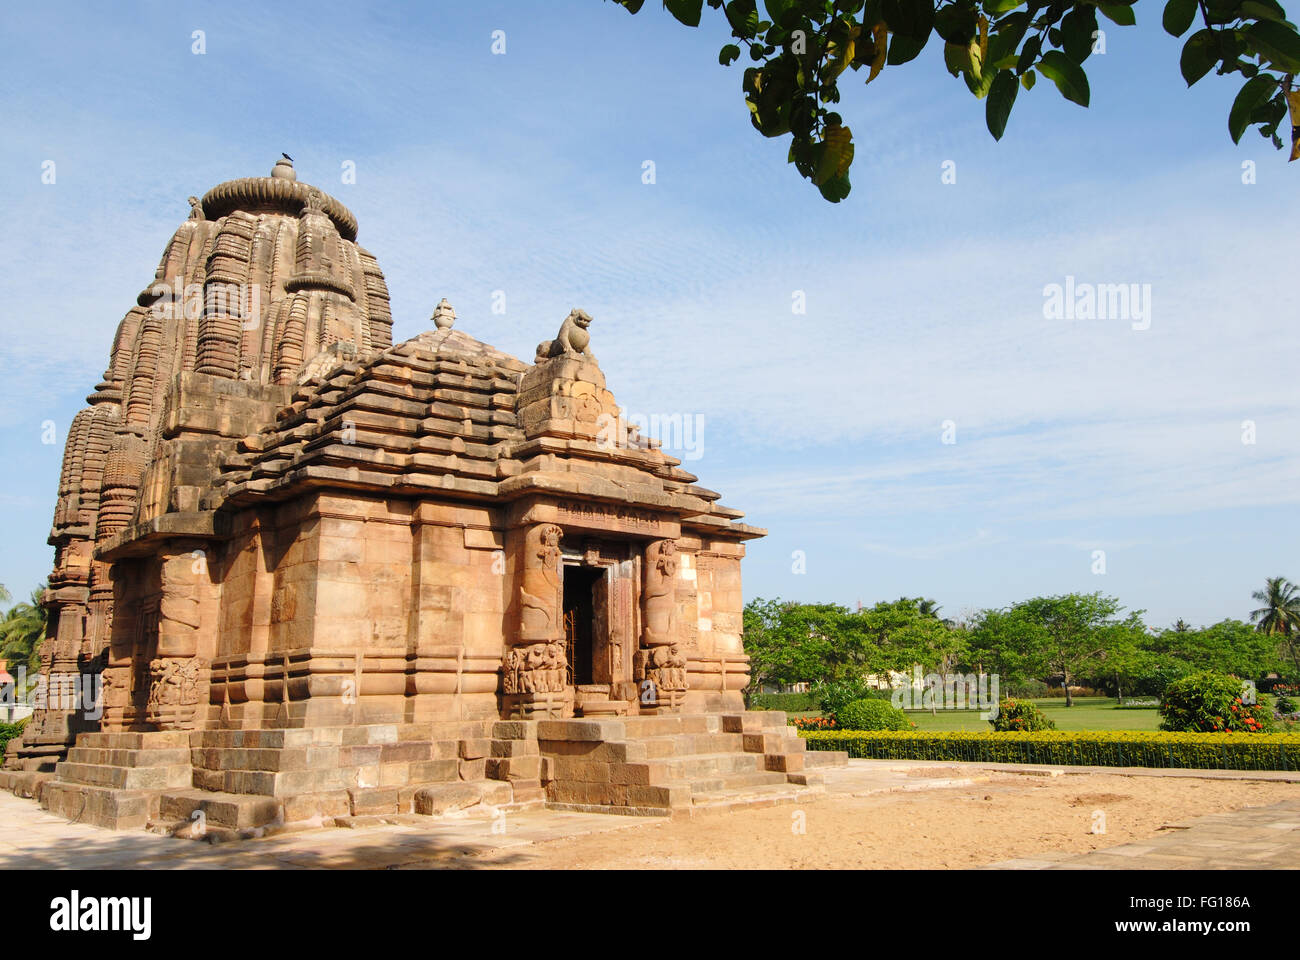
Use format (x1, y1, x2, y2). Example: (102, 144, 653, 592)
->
(208, 325, 761, 539)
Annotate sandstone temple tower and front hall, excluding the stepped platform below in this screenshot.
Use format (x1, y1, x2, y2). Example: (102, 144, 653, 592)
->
(7, 159, 763, 775)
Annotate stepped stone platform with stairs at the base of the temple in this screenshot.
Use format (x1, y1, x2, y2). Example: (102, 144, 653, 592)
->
(20, 712, 848, 836)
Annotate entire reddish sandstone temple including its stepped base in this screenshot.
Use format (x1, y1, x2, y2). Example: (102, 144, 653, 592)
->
(4, 157, 836, 830)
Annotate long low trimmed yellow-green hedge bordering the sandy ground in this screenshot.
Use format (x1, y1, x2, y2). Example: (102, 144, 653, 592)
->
(800, 730, 1300, 770)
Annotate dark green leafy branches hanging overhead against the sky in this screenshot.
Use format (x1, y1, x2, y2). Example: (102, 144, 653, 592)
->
(615, 0, 1300, 203)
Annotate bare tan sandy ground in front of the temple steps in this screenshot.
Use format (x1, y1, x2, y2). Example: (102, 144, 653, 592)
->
(444, 767, 1300, 870)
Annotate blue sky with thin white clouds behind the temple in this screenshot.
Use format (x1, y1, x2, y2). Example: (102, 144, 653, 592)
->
(0, 0, 1300, 624)
